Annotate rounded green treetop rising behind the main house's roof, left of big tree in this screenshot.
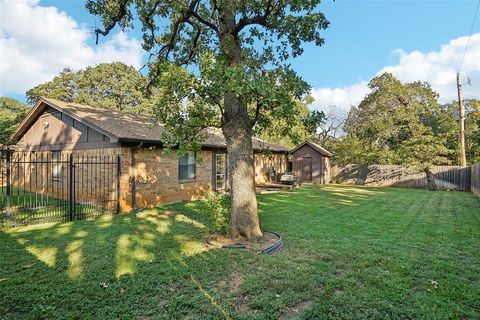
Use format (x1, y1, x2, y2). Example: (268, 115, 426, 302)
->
(26, 62, 152, 113)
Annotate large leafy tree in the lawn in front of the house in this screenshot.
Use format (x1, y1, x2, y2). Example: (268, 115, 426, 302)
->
(86, 0, 328, 238)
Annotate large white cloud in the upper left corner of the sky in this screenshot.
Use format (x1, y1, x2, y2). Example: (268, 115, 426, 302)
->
(0, 0, 144, 94)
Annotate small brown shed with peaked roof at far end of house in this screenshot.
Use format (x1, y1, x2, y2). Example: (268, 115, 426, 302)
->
(290, 141, 332, 184)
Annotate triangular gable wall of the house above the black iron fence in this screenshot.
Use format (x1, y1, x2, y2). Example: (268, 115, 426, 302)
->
(17, 107, 120, 150)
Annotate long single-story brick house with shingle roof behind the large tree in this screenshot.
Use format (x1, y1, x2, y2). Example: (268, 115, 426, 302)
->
(12, 98, 288, 211)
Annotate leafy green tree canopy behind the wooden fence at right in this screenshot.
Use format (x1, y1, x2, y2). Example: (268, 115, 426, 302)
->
(331, 74, 480, 167)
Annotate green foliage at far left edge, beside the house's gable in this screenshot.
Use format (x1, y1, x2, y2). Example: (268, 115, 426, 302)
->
(0, 97, 29, 144)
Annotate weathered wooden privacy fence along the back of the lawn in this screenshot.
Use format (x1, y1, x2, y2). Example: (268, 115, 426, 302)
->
(332, 164, 472, 191)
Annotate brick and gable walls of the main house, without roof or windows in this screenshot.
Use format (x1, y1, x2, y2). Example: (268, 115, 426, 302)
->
(14, 107, 288, 212)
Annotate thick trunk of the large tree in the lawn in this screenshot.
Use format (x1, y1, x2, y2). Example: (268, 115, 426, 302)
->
(219, 1, 262, 239)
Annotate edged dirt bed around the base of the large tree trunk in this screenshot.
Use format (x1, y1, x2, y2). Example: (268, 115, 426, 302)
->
(206, 232, 279, 251)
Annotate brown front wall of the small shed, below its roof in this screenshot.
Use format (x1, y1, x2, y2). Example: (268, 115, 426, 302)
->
(292, 144, 330, 184)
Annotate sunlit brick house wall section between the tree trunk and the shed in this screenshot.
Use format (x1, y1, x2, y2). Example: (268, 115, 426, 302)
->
(254, 153, 288, 184)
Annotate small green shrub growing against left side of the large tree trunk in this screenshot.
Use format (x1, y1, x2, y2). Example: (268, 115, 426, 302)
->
(200, 191, 230, 234)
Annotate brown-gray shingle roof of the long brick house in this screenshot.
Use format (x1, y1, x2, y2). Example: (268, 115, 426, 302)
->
(12, 98, 288, 152)
